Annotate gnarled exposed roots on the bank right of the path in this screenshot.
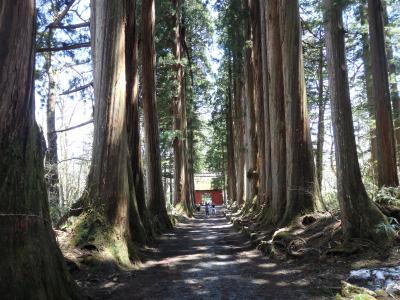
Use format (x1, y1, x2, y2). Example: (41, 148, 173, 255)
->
(231, 207, 390, 259)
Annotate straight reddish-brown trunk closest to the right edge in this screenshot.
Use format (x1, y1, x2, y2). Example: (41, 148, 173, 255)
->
(368, 0, 399, 187)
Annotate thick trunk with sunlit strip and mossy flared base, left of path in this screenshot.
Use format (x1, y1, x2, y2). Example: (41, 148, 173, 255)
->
(74, 0, 146, 266)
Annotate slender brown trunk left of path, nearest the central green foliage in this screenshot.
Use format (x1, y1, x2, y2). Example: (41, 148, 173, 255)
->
(142, 0, 172, 231)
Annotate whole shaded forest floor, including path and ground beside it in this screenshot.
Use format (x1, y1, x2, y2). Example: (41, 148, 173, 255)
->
(54, 211, 398, 299)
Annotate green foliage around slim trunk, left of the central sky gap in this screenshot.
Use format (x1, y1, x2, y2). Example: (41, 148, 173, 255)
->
(156, 0, 213, 176)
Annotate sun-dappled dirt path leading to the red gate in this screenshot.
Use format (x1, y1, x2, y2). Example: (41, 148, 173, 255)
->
(81, 212, 340, 300)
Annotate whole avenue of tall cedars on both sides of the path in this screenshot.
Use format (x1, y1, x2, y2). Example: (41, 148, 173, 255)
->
(0, 0, 400, 299)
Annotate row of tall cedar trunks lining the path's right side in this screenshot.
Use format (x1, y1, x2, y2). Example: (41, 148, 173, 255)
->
(217, 0, 398, 241)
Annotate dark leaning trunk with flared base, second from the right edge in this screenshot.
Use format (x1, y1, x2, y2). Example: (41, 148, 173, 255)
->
(324, 0, 387, 241)
